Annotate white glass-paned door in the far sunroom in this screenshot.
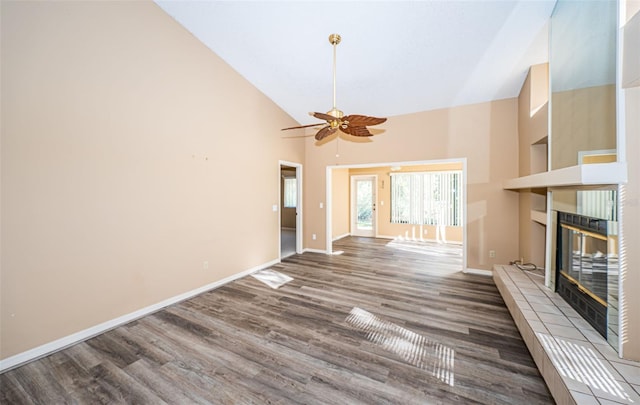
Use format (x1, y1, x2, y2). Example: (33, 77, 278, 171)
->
(351, 176, 377, 237)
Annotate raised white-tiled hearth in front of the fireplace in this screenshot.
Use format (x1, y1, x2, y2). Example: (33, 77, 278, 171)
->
(493, 265, 640, 405)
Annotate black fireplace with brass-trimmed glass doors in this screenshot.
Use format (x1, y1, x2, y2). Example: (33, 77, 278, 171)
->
(556, 212, 617, 338)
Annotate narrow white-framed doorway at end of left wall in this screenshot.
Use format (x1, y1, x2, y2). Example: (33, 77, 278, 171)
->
(279, 161, 302, 259)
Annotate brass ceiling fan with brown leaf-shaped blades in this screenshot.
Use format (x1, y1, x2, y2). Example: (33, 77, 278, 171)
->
(282, 34, 387, 141)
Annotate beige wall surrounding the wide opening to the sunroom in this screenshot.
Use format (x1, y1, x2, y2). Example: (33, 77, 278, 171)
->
(304, 99, 518, 270)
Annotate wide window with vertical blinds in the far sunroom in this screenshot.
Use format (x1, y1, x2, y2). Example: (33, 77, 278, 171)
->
(391, 171, 462, 226)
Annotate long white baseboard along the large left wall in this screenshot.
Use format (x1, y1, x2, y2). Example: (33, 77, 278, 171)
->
(0, 258, 280, 373)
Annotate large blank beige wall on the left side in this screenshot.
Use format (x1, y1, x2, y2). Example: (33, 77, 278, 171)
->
(0, 1, 304, 358)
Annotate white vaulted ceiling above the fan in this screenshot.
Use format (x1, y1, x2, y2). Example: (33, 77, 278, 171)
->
(156, 0, 555, 124)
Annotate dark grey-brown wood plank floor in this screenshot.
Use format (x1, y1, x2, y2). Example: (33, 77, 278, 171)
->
(0, 237, 553, 404)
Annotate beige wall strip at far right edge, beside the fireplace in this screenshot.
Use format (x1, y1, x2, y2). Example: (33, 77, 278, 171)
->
(621, 0, 640, 361)
